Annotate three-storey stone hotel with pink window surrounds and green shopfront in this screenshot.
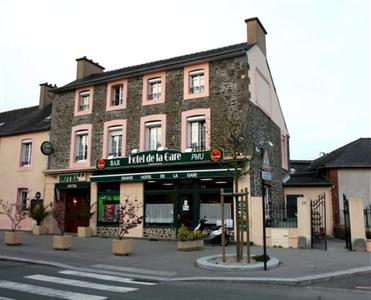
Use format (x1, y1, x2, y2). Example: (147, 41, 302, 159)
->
(45, 18, 289, 239)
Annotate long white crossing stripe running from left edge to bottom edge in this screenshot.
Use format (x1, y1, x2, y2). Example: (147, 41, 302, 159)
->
(0, 280, 107, 300)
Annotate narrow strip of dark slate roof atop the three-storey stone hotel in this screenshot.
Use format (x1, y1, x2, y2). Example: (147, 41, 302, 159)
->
(53, 42, 253, 93)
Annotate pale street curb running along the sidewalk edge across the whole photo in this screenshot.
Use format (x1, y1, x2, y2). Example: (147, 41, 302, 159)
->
(0, 255, 371, 286)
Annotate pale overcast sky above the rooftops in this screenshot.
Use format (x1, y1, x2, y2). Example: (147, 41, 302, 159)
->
(0, 0, 371, 159)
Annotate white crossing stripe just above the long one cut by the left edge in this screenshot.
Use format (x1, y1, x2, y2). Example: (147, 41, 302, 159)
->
(24, 274, 137, 293)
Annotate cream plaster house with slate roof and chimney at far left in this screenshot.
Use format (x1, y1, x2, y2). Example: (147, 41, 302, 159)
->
(0, 83, 56, 230)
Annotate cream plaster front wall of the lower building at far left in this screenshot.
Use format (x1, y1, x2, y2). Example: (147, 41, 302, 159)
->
(0, 131, 49, 230)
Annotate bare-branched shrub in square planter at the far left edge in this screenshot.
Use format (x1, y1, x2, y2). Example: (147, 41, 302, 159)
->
(0, 199, 28, 246)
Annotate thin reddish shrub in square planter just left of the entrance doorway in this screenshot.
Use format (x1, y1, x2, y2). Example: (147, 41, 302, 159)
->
(52, 201, 72, 250)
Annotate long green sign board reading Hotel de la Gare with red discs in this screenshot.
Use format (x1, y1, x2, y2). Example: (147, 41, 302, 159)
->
(96, 150, 223, 170)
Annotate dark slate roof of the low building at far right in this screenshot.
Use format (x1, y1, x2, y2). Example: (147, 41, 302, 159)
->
(310, 138, 371, 170)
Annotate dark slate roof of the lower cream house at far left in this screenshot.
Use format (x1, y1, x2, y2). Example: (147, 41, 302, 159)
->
(0, 104, 52, 137)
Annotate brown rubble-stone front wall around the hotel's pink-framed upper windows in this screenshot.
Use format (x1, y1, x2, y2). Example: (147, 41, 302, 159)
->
(49, 56, 247, 169)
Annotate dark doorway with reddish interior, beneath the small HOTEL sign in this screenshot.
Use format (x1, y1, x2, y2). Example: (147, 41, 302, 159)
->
(64, 189, 90, 232)
